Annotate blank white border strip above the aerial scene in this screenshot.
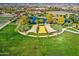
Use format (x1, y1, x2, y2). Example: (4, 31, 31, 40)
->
(0, 0, 79, 3)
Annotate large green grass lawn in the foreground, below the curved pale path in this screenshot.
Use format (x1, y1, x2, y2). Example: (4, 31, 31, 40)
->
(0, 22, 79, 56)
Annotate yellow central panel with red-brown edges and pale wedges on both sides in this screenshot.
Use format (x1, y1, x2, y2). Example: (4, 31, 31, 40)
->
(19, 24, 56, 34)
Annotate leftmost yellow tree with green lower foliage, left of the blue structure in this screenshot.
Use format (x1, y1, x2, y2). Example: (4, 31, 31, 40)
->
(16, 15, 29, 31)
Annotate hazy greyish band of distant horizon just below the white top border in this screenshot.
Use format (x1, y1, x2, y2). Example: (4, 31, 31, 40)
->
(0, 3, 79, 7)
